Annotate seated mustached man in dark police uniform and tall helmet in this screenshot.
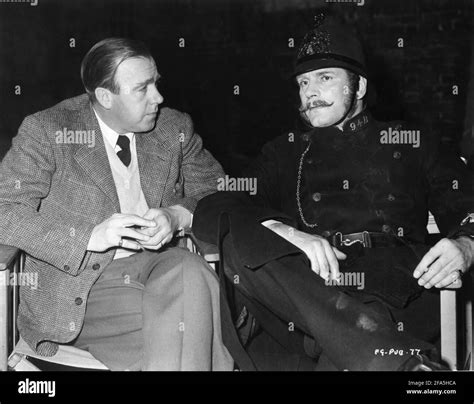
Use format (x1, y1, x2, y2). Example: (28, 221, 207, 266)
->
(193, 16, 474, 370)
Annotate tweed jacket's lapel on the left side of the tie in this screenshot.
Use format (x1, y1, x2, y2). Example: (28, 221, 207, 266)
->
(74, 103, 120, 212)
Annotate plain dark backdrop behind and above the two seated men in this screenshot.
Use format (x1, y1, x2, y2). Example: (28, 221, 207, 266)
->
(0, 0, 474, 174)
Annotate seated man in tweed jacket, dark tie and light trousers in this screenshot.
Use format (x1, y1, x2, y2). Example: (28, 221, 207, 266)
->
(0, 38, 233, 370)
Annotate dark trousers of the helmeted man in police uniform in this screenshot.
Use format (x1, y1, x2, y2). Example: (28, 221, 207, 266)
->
(223, 236, 439, 370)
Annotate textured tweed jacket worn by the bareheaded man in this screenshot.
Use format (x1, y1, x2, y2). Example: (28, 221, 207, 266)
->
(0, 94, 223, 356)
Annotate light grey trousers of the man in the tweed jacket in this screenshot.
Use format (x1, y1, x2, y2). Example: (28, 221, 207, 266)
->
(73, 247, 234, 371)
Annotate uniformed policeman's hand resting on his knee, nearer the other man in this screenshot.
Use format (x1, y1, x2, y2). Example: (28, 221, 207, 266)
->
(262, 220, 347, 280)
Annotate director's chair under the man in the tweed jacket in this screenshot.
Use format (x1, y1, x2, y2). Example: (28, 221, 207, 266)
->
(0, 233, 219, 371)
